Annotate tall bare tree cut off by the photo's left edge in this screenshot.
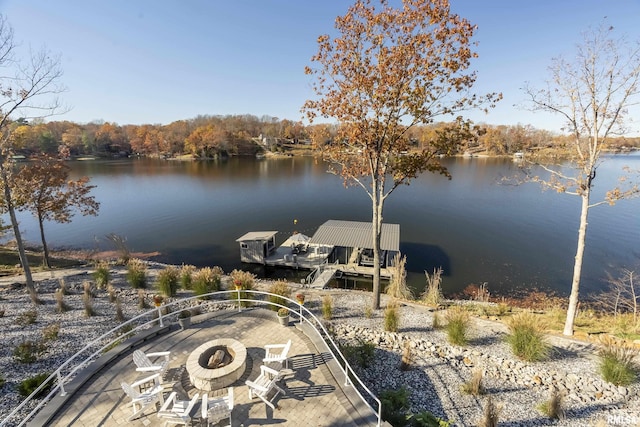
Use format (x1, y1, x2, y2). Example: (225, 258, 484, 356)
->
(0, 15, 63, 302)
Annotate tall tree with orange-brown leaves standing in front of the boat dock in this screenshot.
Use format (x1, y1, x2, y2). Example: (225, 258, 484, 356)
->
(303, 0, 499, 309)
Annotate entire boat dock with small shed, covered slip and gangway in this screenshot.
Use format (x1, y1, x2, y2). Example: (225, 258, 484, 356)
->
(236, 220, 400, 288)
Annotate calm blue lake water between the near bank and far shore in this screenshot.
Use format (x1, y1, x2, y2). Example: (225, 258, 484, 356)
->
(10, 154, 640, 295)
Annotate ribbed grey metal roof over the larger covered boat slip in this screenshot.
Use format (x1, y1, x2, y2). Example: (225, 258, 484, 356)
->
(311, 219, 400, 252)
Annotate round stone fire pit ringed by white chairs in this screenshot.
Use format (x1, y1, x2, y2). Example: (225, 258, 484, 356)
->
(186, 338, 247, 391)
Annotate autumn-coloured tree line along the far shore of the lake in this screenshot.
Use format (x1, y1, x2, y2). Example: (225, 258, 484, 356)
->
(11, 114, 640, 158)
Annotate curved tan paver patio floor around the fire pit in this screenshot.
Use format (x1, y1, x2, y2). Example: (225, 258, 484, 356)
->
(37, 308, 377, 427)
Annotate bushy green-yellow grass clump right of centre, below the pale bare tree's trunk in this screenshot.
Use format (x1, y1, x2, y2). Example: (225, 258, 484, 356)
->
(506, 311, 551, 362)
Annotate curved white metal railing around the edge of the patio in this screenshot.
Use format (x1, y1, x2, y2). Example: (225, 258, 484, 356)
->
(0, 289, 382, 427)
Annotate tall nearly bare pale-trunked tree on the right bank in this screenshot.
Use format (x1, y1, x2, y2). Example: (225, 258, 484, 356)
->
(525, 26, 640, 335)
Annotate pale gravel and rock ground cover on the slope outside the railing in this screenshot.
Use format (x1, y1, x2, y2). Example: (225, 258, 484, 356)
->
(0, 263, 640, 426)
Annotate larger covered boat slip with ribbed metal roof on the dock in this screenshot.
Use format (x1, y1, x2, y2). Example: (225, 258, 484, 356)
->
(311, 219, 400, 267)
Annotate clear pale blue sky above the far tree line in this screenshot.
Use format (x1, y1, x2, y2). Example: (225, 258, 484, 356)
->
(0, 0, 640, 133)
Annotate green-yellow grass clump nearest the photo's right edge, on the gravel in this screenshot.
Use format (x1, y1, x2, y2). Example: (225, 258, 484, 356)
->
(598, 337, 638, 386)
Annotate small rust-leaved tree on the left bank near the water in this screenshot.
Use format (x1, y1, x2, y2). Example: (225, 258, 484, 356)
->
(13, 150, 100, 268)
